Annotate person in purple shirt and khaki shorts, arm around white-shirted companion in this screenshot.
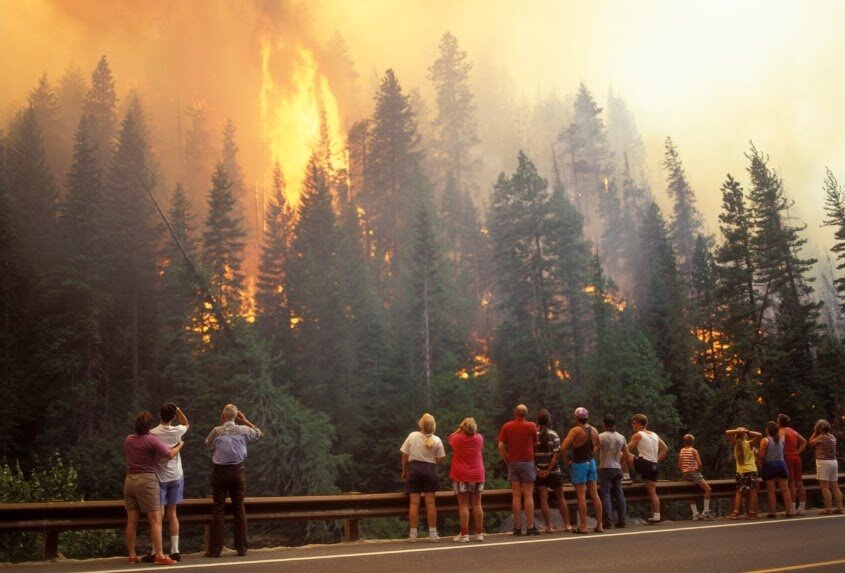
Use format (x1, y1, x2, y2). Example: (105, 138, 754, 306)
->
(123, 412, 185, 565)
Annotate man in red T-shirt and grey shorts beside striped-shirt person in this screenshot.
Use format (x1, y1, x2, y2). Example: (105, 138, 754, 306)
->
(499, 404, 540, 535)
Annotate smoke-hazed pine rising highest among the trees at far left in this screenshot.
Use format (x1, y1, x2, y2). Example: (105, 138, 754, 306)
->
(83, 56, 117, 169)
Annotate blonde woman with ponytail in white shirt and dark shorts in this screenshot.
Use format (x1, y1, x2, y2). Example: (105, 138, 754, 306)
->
(400, 413, 446, 542)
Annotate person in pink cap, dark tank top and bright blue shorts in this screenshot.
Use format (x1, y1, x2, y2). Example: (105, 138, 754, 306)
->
(560, 408, 604, 534)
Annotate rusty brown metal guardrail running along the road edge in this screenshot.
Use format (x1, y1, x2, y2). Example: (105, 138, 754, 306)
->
(0, 473, 845, 559)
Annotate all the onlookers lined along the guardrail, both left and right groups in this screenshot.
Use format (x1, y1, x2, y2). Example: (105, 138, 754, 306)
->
(124, 402, 842, 565)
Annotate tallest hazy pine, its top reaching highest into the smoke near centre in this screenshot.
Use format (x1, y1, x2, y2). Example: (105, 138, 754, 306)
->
(428, 32, 479, 196)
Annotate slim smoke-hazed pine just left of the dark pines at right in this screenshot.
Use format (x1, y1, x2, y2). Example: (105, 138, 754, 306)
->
(663, 137, 701, 282)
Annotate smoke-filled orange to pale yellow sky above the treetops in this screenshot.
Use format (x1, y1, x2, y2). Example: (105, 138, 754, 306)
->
(0, 0, 845, 250)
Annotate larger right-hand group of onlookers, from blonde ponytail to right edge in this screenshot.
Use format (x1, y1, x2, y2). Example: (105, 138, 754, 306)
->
(401, 404, 842, 543)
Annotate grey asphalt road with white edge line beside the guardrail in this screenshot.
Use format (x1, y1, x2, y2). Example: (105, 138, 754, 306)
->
(6, 515, 845, 573)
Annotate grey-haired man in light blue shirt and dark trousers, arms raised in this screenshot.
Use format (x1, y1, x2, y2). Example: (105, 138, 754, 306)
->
(205, 404, 264, 557)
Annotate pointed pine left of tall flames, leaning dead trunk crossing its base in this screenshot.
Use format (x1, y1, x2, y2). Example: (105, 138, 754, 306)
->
(202, 161, 246, 322)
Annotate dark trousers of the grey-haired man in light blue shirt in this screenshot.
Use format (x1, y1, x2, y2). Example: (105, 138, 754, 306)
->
(208, 464, 246, 555)
